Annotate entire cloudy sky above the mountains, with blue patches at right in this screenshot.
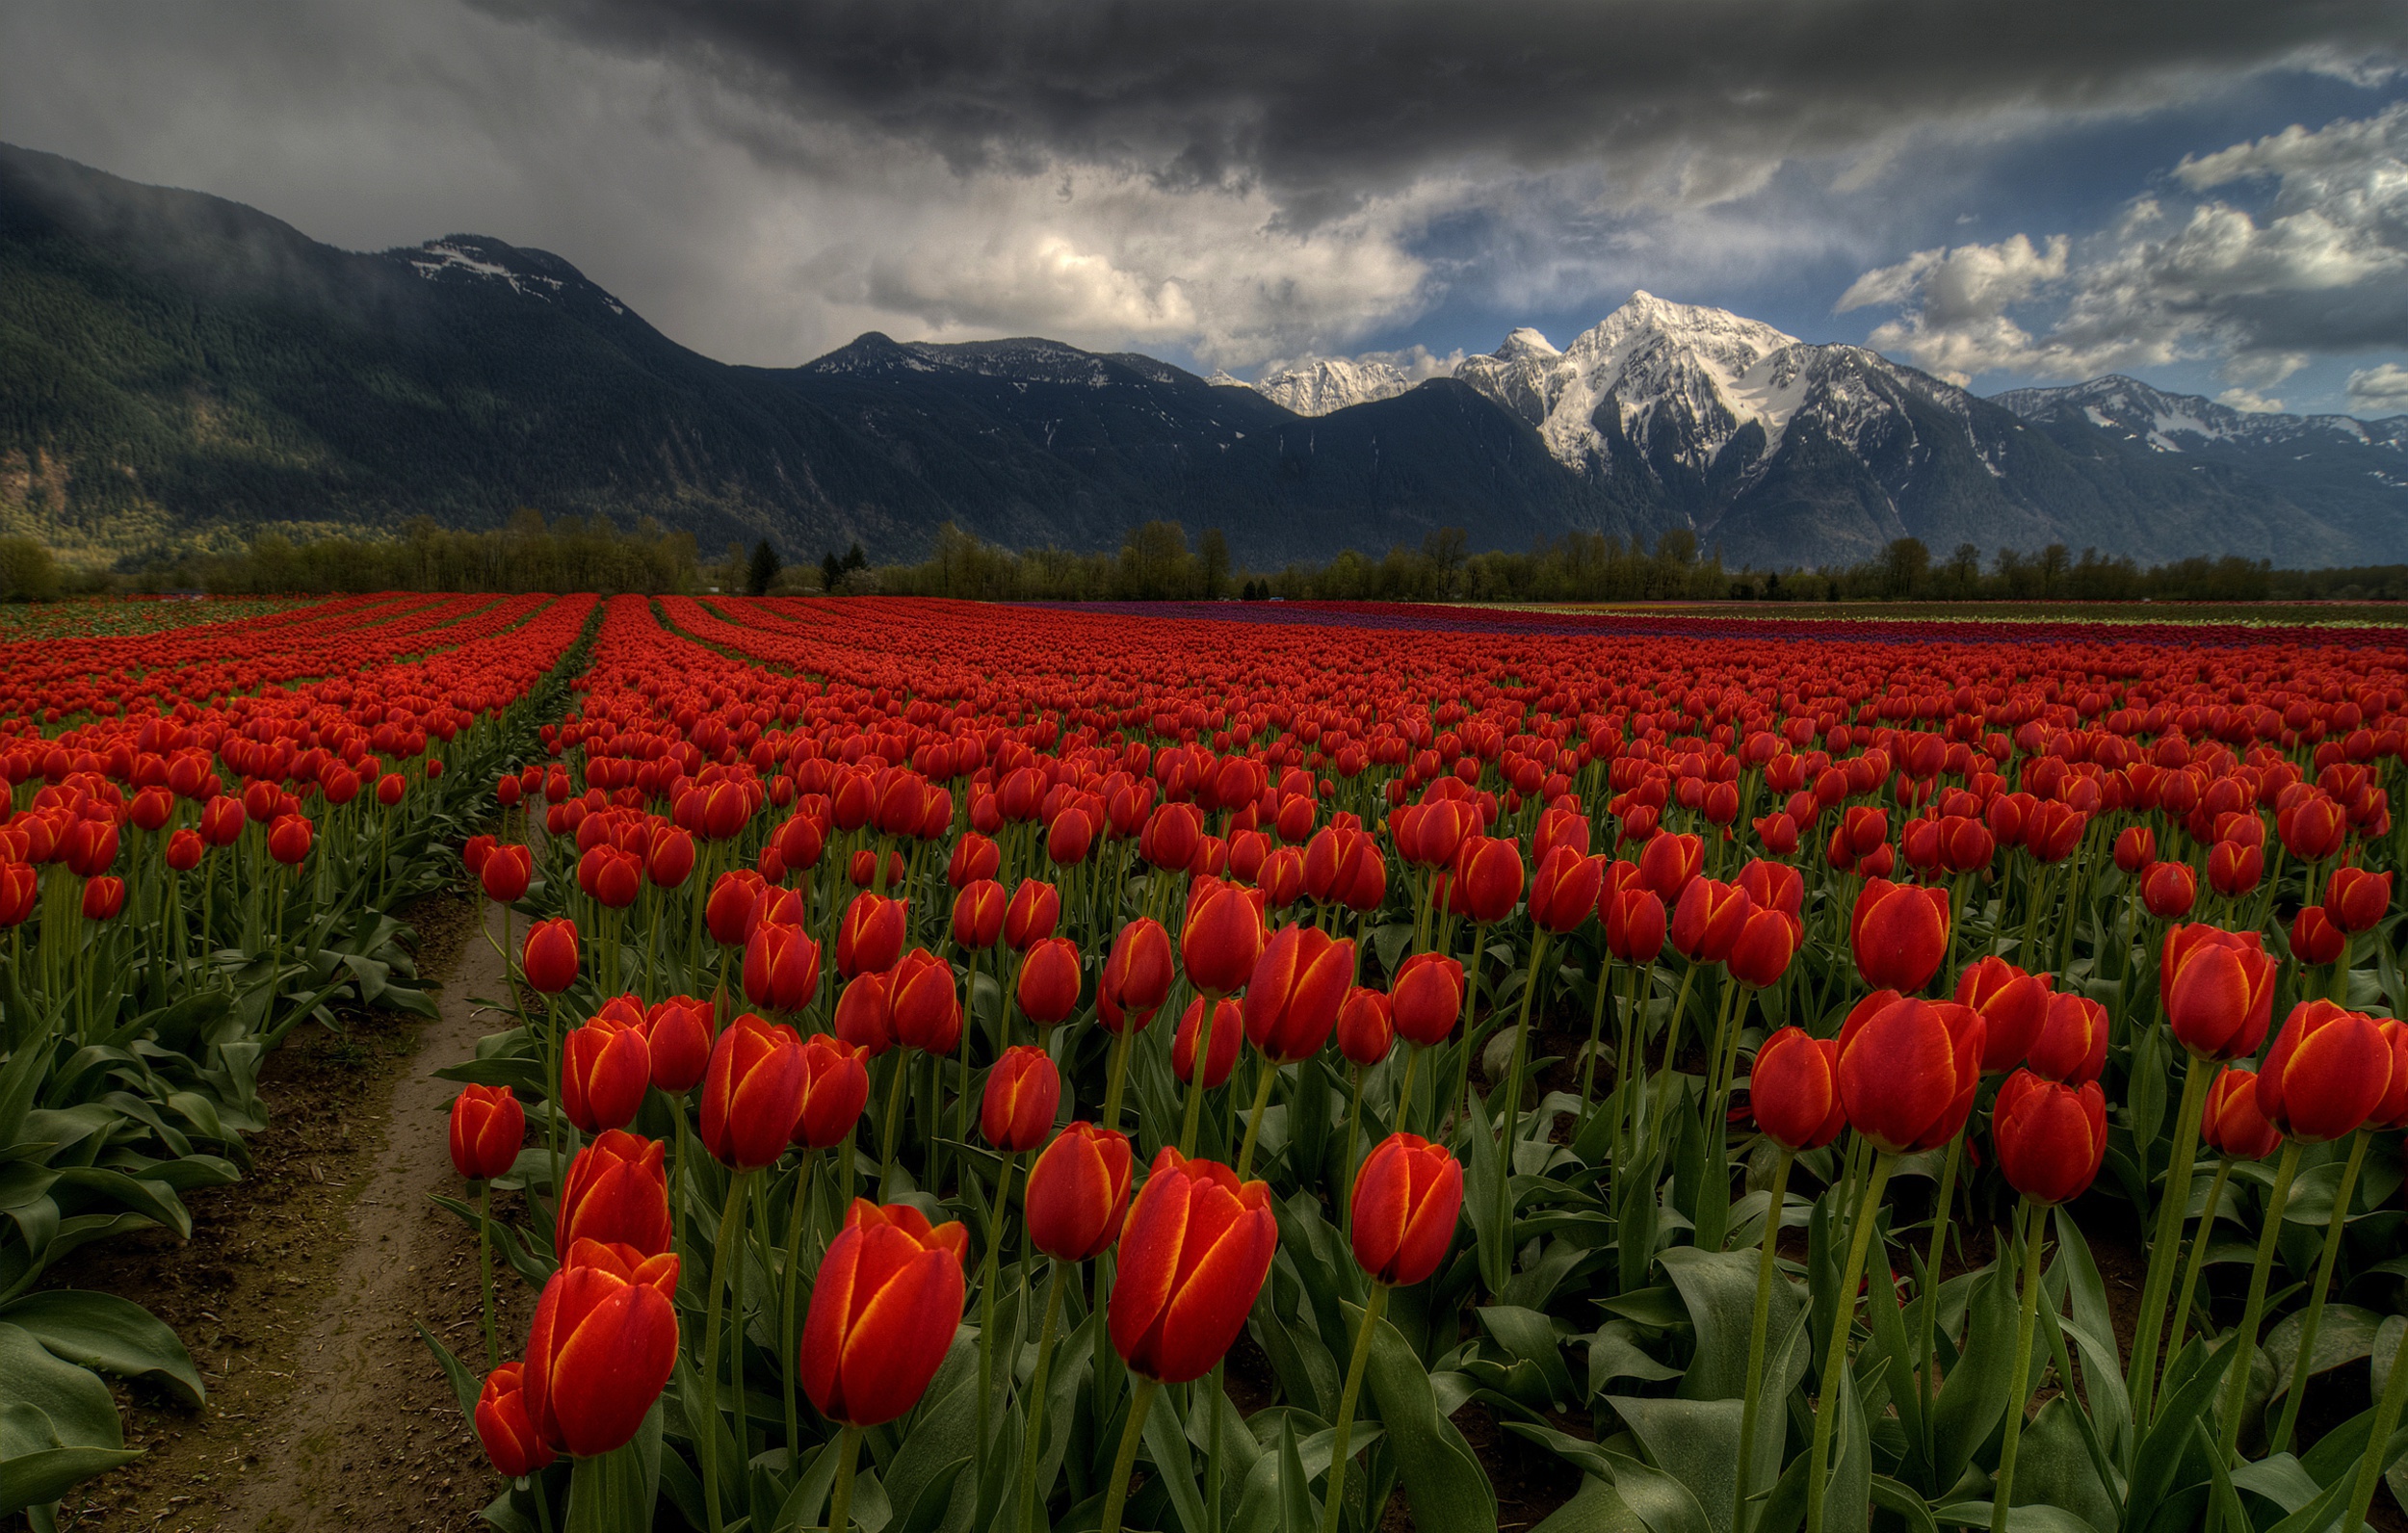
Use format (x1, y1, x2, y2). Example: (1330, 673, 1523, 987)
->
(0, 0, 2408, 414)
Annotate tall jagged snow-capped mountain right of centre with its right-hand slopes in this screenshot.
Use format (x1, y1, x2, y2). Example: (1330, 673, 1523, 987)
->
(1454, 294, 2408, 565)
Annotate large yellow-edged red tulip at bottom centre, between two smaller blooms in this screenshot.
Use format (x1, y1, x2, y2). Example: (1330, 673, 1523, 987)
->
(1108, 1146, 1279, 1384)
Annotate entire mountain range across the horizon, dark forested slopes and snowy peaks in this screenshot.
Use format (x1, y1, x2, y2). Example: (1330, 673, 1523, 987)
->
(0, 146, 2408, 568)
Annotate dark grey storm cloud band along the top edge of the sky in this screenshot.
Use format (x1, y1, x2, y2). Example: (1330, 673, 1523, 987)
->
(480, 0, 2408, 219)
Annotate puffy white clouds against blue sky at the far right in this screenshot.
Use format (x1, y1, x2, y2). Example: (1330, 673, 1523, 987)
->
(1838, 103, 2408, 390)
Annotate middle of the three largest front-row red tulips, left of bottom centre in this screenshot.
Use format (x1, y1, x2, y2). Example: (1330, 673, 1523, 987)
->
(802, 1199, 971, 1427)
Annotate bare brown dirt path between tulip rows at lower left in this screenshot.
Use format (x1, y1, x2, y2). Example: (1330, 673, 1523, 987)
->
(56, 897, 535, 1533)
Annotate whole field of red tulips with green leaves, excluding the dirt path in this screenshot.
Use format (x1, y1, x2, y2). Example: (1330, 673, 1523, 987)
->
(0, 594, 2408, 1533)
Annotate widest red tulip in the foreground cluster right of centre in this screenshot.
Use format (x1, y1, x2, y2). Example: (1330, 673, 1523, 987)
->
(1840, 997, 1982, 1156)
